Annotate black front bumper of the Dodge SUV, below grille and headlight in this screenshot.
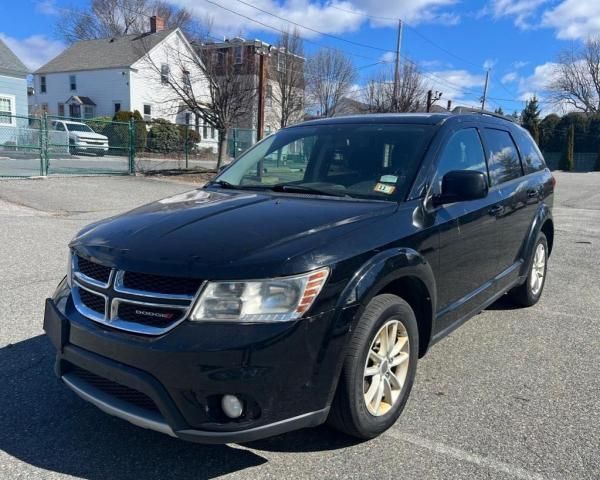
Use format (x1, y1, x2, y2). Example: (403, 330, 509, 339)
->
(44, 289, 355, 443)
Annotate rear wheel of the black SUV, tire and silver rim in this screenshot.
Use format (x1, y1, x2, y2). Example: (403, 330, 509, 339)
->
(508, 232, 548, 307)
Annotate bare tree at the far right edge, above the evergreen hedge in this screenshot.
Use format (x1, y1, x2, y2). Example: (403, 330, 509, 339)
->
(548, 37, 600, 113)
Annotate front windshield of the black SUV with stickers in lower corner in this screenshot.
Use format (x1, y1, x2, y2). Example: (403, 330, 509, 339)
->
(211, 123, 433, 201)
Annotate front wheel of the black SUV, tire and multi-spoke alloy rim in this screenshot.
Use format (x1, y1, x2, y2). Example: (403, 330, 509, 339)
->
(327, 294, 419, 440)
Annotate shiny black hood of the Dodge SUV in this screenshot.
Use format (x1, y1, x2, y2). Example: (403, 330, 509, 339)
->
(71, 189, 398, 280)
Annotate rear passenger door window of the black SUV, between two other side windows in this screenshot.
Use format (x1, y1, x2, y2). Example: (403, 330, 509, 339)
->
(484, 128, 522, 186)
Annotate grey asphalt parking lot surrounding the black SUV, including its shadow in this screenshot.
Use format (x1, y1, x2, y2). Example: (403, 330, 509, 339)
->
(0, 173, 600, 480)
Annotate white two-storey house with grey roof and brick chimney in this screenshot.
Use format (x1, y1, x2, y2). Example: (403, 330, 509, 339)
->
(30, 17, 217, 148)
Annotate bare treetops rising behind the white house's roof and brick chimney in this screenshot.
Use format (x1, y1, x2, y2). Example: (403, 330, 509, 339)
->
(56, 0, 194, 43)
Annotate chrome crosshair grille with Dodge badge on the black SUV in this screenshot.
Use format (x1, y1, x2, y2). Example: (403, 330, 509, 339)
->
(72, 256, 203, 335)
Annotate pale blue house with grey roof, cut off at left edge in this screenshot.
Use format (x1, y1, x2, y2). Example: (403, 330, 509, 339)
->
(0, 40, 29, 126)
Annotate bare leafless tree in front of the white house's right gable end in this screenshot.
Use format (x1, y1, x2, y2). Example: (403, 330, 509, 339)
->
(144, 36, 257, 168)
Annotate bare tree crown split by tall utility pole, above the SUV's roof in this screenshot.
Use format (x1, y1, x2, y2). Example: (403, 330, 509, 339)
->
(363, 62, 425, 113)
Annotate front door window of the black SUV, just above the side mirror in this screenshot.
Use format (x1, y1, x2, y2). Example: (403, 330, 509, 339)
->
(437, 128, 487, 191)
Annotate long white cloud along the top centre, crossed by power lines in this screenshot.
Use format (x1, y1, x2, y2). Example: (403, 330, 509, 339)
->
(168, 0, 460, 38)
